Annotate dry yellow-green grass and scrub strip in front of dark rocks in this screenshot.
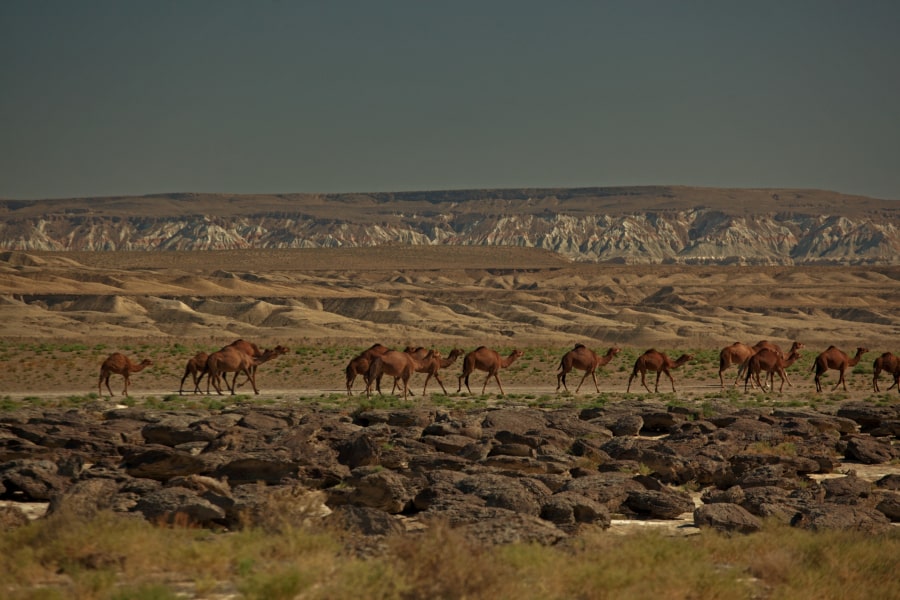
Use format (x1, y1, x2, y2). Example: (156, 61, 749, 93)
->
(0, 507, 900, 600)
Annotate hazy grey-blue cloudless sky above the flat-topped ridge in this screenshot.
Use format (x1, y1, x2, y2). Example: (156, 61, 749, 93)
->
(0, 0, 900, 199)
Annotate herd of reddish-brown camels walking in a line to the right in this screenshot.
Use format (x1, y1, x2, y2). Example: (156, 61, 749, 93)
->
(97, 339, 900, 399)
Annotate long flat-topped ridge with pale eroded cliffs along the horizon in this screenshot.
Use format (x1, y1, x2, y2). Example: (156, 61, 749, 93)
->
(0, 188, 900, 265)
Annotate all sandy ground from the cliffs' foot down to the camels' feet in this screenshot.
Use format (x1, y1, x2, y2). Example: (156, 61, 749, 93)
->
(0, 246, 900, 401)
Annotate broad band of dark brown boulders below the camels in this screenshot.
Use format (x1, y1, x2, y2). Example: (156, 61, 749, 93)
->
(0, 400, 900, 543)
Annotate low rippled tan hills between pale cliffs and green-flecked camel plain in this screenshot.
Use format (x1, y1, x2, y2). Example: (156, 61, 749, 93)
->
(0, 246, 900, 351)
